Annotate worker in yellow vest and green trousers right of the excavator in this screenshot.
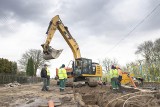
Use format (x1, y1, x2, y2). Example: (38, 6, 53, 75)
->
(109, 65, 119, 90)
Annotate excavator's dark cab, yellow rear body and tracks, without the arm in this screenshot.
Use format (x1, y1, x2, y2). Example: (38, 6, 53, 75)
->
(72, 58, 102, 86)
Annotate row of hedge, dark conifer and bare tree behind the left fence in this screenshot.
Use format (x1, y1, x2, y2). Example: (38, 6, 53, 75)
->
(0, 49, 47, 76)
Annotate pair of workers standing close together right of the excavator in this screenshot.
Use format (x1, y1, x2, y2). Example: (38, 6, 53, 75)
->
(109, 65, 122, 90)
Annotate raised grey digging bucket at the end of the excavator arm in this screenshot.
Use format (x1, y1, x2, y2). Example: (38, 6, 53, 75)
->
(43, 48, 63, 60)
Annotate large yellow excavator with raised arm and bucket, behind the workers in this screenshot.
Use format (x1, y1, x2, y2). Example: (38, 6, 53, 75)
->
(41, 15, 102, 86)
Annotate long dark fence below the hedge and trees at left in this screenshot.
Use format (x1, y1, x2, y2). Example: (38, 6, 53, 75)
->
(0, 74, 41, 84)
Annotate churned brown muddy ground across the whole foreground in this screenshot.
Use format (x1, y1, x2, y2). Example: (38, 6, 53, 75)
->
(0, 80, 160, 107)
